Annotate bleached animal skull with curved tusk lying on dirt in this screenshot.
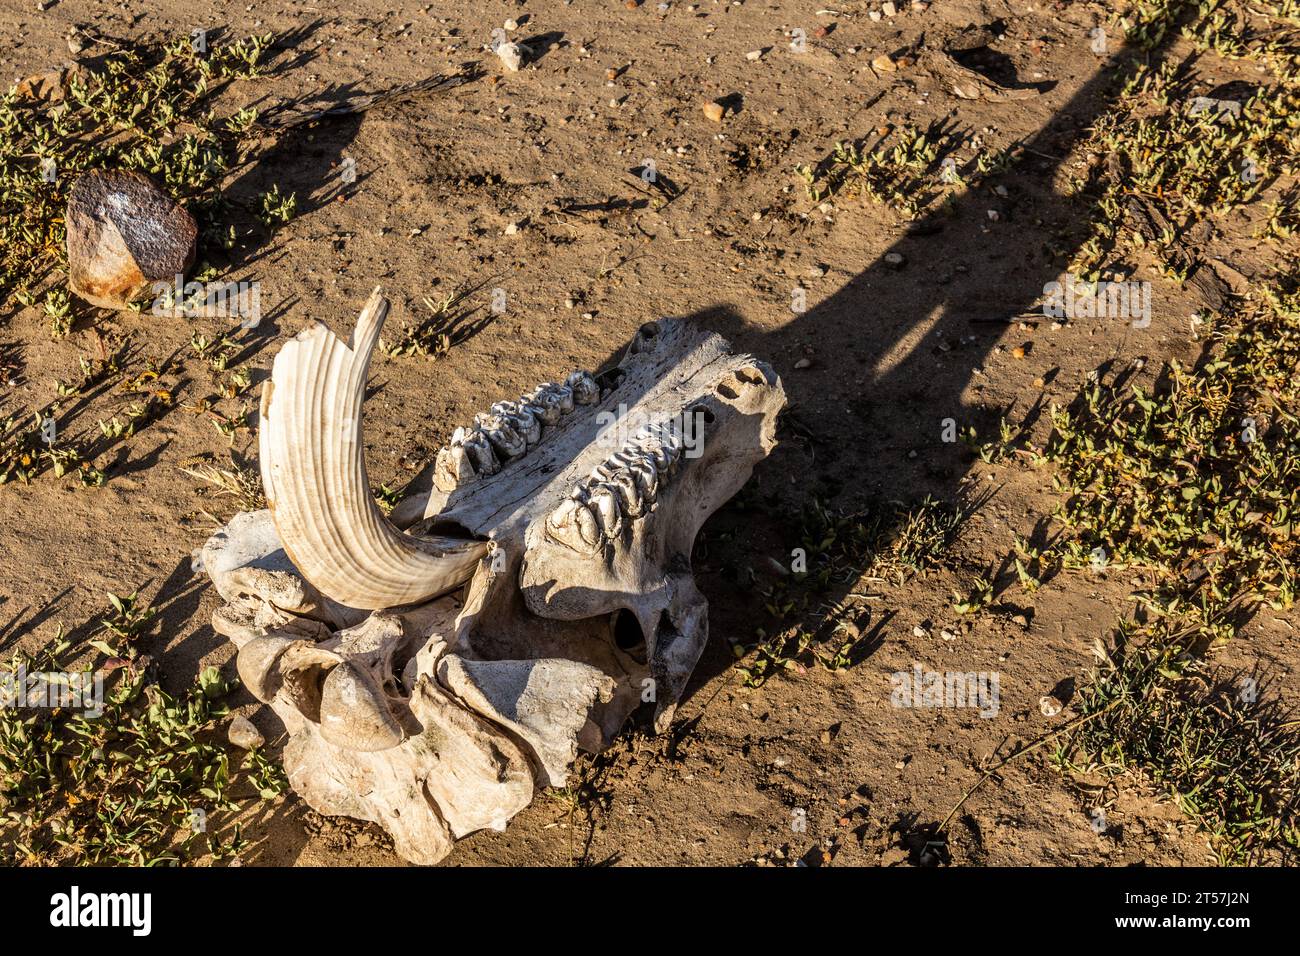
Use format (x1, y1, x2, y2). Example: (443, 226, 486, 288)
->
(196, 290, 785, 864)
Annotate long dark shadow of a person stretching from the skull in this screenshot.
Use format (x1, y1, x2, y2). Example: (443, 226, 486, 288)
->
(650, 13, 1206, 719)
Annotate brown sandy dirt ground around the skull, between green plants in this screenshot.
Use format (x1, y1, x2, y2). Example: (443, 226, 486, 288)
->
(0, 0, 1295, 865)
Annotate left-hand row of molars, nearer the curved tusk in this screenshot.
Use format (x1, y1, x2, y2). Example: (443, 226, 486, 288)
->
(433, 371, 601, 492)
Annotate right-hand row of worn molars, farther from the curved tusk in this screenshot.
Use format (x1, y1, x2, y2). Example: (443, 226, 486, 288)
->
(546, 423, 683, 554)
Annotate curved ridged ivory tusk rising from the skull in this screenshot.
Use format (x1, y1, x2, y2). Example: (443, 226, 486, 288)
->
(259, 289, 488, 610)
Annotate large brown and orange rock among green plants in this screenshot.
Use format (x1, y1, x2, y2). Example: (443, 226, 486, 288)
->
(66, 169, 198, 310)
